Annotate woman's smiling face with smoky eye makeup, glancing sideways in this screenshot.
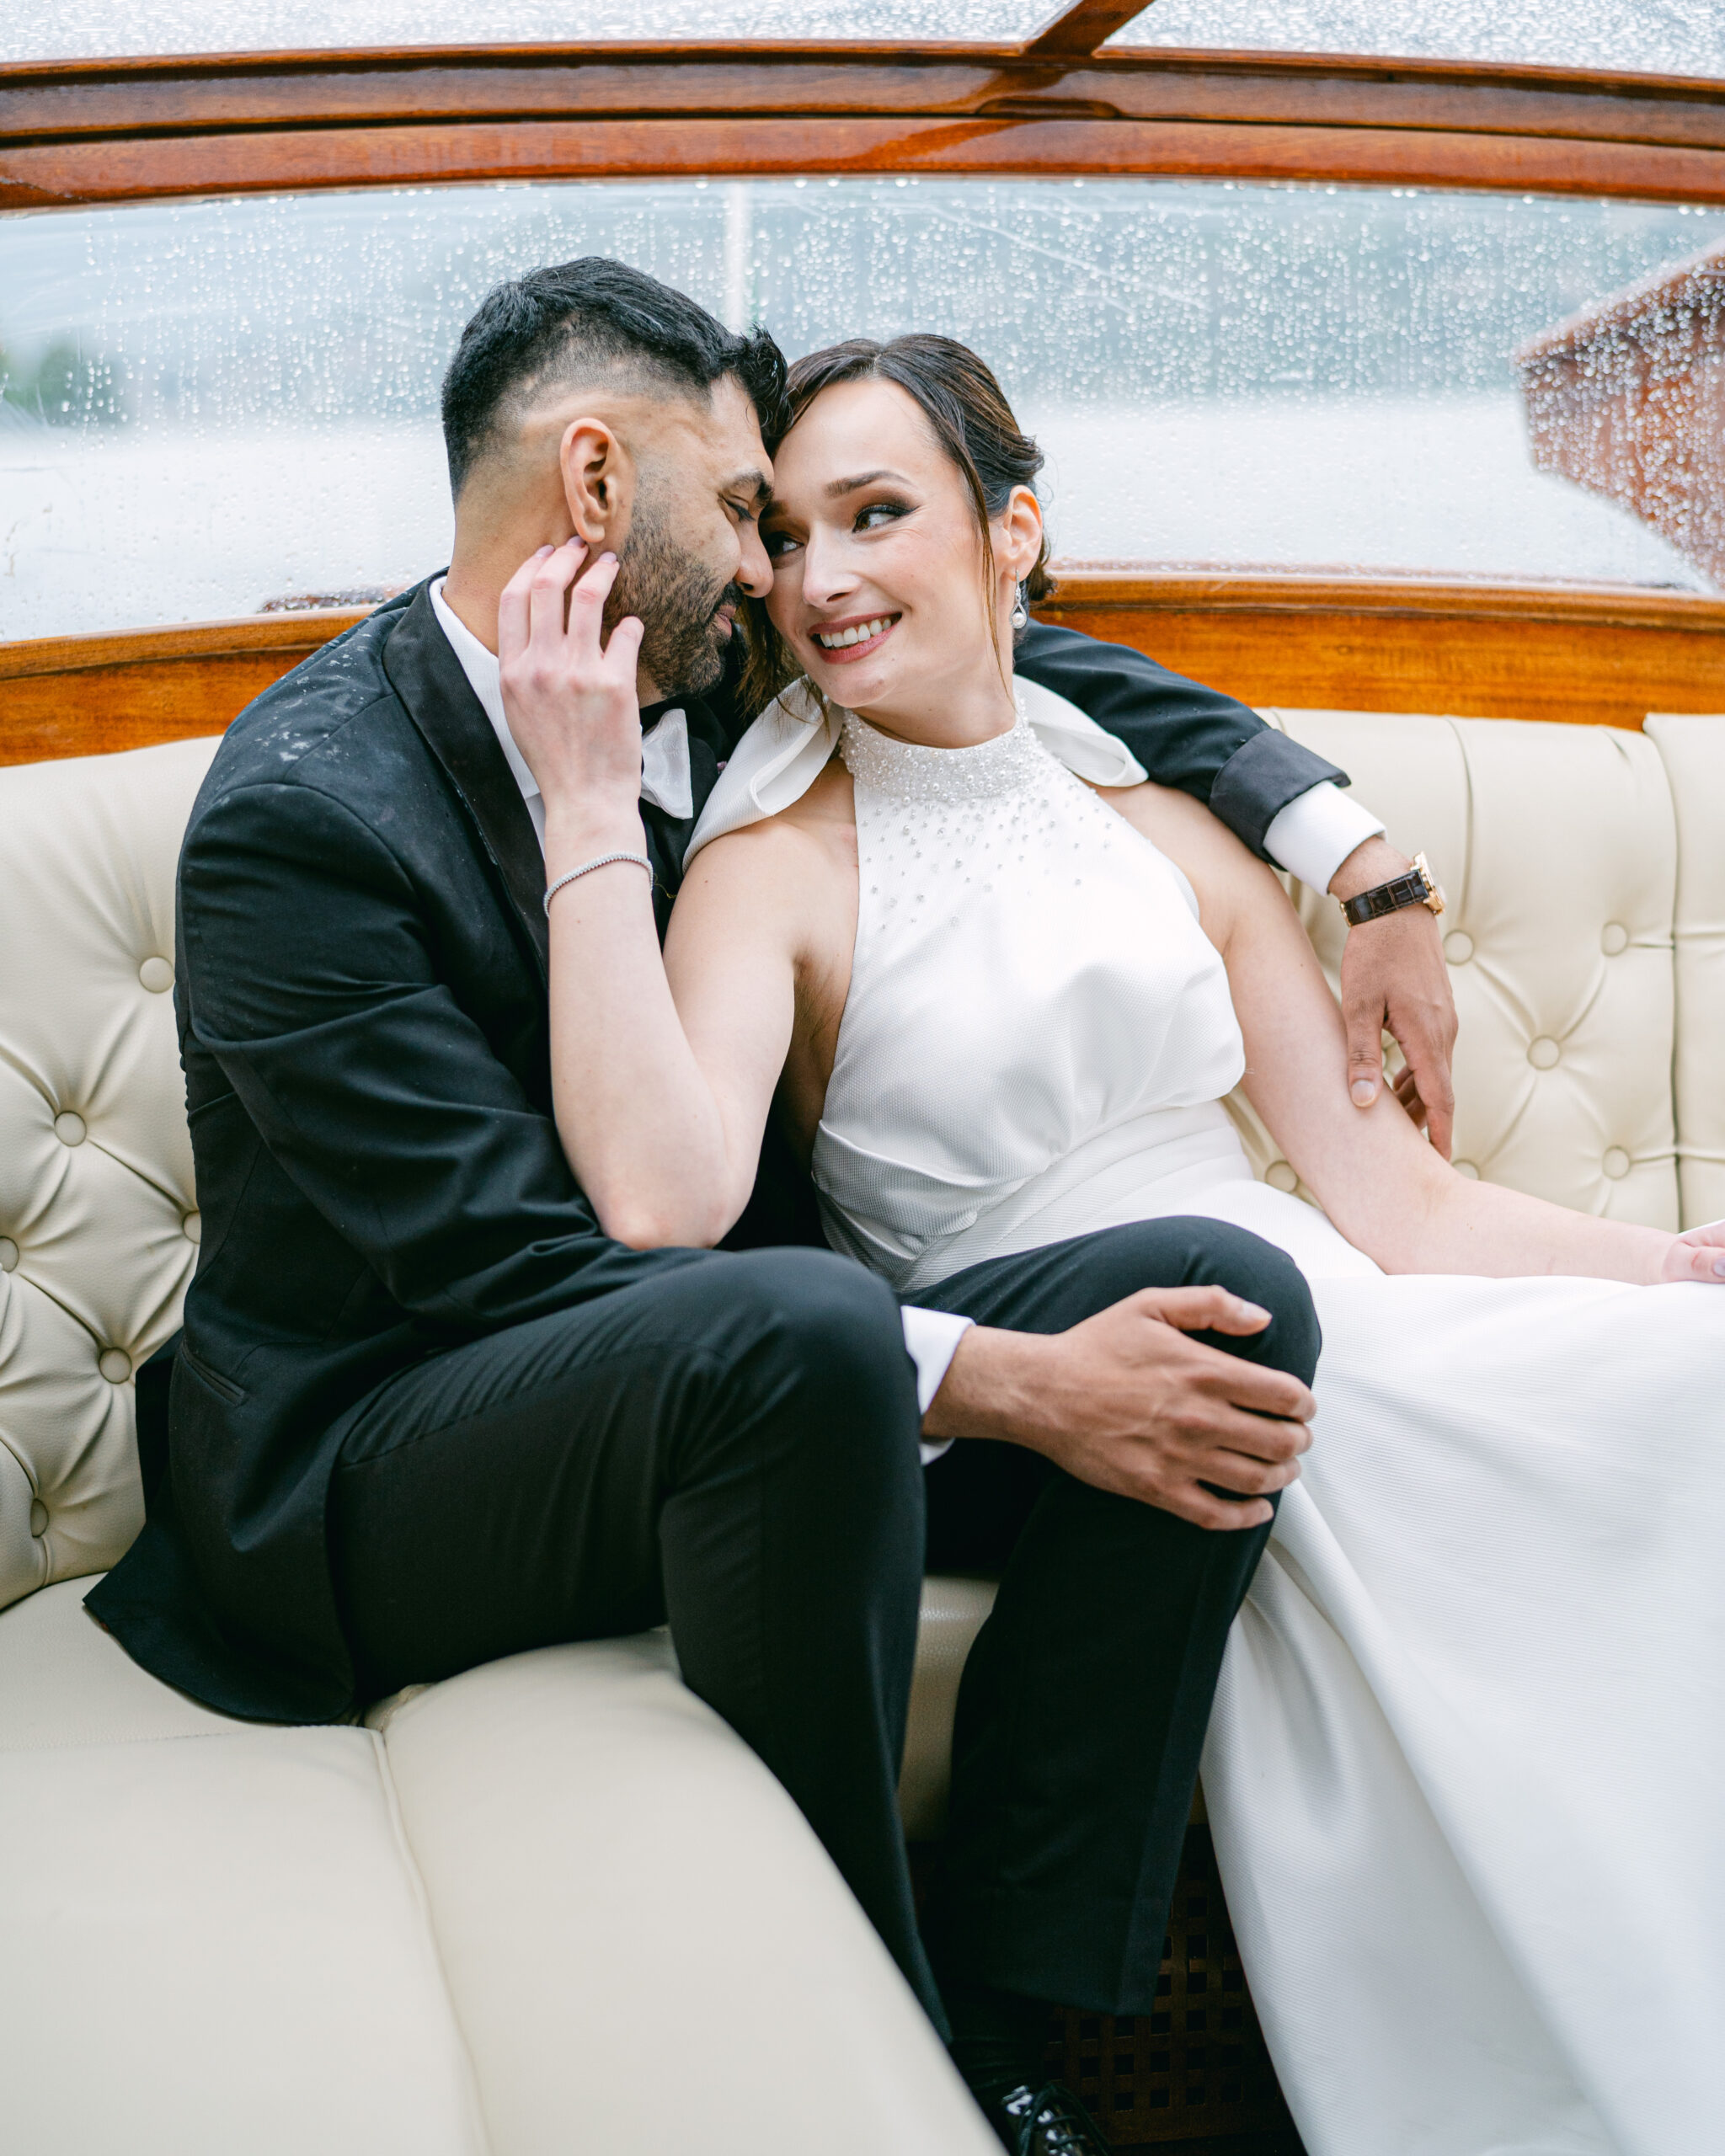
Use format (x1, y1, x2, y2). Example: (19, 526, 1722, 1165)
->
(761, 380, 1041, 739)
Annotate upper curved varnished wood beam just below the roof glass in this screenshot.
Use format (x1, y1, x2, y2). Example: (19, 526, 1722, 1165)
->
(0, 45, 1725, 149)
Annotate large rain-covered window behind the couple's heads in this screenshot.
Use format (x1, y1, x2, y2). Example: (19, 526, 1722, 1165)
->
(0, 179, 1725, 636)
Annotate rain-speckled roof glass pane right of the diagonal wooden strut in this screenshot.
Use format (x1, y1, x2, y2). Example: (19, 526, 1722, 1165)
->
(1113, 0, 1725, 77)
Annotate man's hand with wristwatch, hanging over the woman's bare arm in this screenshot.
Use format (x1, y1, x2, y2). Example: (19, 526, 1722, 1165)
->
(1331, 839, 1455, 1160)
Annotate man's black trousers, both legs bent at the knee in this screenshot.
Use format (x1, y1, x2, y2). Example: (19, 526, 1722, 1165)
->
(328, 1220, 1316, 2025)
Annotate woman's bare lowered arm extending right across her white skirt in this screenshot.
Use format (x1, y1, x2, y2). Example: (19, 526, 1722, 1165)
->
(1102, 787, 1725, 1281)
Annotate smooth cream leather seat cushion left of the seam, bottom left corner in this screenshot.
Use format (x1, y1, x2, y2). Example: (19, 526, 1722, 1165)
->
(0, 1582, 485, 2156)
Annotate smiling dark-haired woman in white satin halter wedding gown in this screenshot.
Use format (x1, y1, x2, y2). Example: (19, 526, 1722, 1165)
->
(528, 339, 1725, 2156)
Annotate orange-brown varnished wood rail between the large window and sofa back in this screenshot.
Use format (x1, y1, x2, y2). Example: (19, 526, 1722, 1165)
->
(0, 563, 1725, 763)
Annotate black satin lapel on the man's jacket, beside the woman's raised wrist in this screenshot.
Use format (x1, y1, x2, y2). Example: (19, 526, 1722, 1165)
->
(384, 582, 550, 981)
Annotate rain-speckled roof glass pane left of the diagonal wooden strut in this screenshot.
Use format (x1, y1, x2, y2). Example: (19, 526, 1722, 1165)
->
(0, 0, 1056, 62)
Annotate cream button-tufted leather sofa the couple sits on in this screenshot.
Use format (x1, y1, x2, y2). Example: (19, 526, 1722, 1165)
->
(0, 712, 1725, 2156)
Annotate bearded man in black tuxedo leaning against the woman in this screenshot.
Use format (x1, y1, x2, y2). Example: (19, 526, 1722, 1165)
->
(88, 261, 1440, 2152)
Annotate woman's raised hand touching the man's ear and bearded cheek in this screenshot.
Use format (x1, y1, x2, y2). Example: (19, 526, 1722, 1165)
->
(498, 539, 643, 846)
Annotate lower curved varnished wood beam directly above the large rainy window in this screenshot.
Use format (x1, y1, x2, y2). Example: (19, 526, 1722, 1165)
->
(13, 115, 1725, 209)
